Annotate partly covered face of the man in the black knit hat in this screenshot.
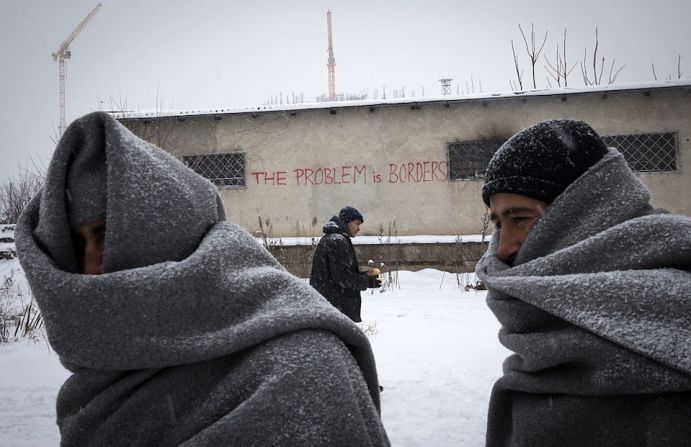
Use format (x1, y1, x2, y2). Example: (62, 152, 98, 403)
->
(489, 192, 547, 265)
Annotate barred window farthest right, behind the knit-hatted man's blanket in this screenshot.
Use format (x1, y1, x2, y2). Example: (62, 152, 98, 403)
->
(602, 132, 679, 172)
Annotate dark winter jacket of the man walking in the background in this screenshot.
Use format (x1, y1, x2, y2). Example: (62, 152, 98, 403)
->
(310, 216, 368, 322)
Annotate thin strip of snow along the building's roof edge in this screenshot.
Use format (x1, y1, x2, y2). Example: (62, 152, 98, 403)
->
(109, 80, 691, 119)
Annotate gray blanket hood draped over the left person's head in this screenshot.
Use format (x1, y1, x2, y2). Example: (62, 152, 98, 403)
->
(22, 112, 225, 273)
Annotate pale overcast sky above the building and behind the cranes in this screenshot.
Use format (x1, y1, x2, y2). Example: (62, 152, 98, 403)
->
(0, 0, 691, 183)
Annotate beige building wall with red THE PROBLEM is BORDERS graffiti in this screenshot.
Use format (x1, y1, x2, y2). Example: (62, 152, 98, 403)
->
(122, 85, 691, 236)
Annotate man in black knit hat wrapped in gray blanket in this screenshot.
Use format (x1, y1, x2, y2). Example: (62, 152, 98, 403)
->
(476, 120, 691, 447)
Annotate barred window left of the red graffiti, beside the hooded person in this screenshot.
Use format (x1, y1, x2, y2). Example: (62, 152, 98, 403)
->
(182, 152, 245, 188)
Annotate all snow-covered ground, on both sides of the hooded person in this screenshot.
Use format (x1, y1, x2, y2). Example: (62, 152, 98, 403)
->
(0, 266, 507, 447)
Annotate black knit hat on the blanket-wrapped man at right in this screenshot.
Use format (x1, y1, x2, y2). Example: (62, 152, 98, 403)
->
(482, 120, 607, 206)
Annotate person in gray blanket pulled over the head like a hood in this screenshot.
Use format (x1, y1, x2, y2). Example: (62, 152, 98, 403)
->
(16, 113, 389, 446)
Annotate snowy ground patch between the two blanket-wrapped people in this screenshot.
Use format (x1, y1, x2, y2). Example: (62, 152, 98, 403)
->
(363, 270, 508, 446)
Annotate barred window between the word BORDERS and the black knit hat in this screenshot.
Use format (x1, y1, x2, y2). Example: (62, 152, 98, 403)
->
(447, 140, 504, 180)
